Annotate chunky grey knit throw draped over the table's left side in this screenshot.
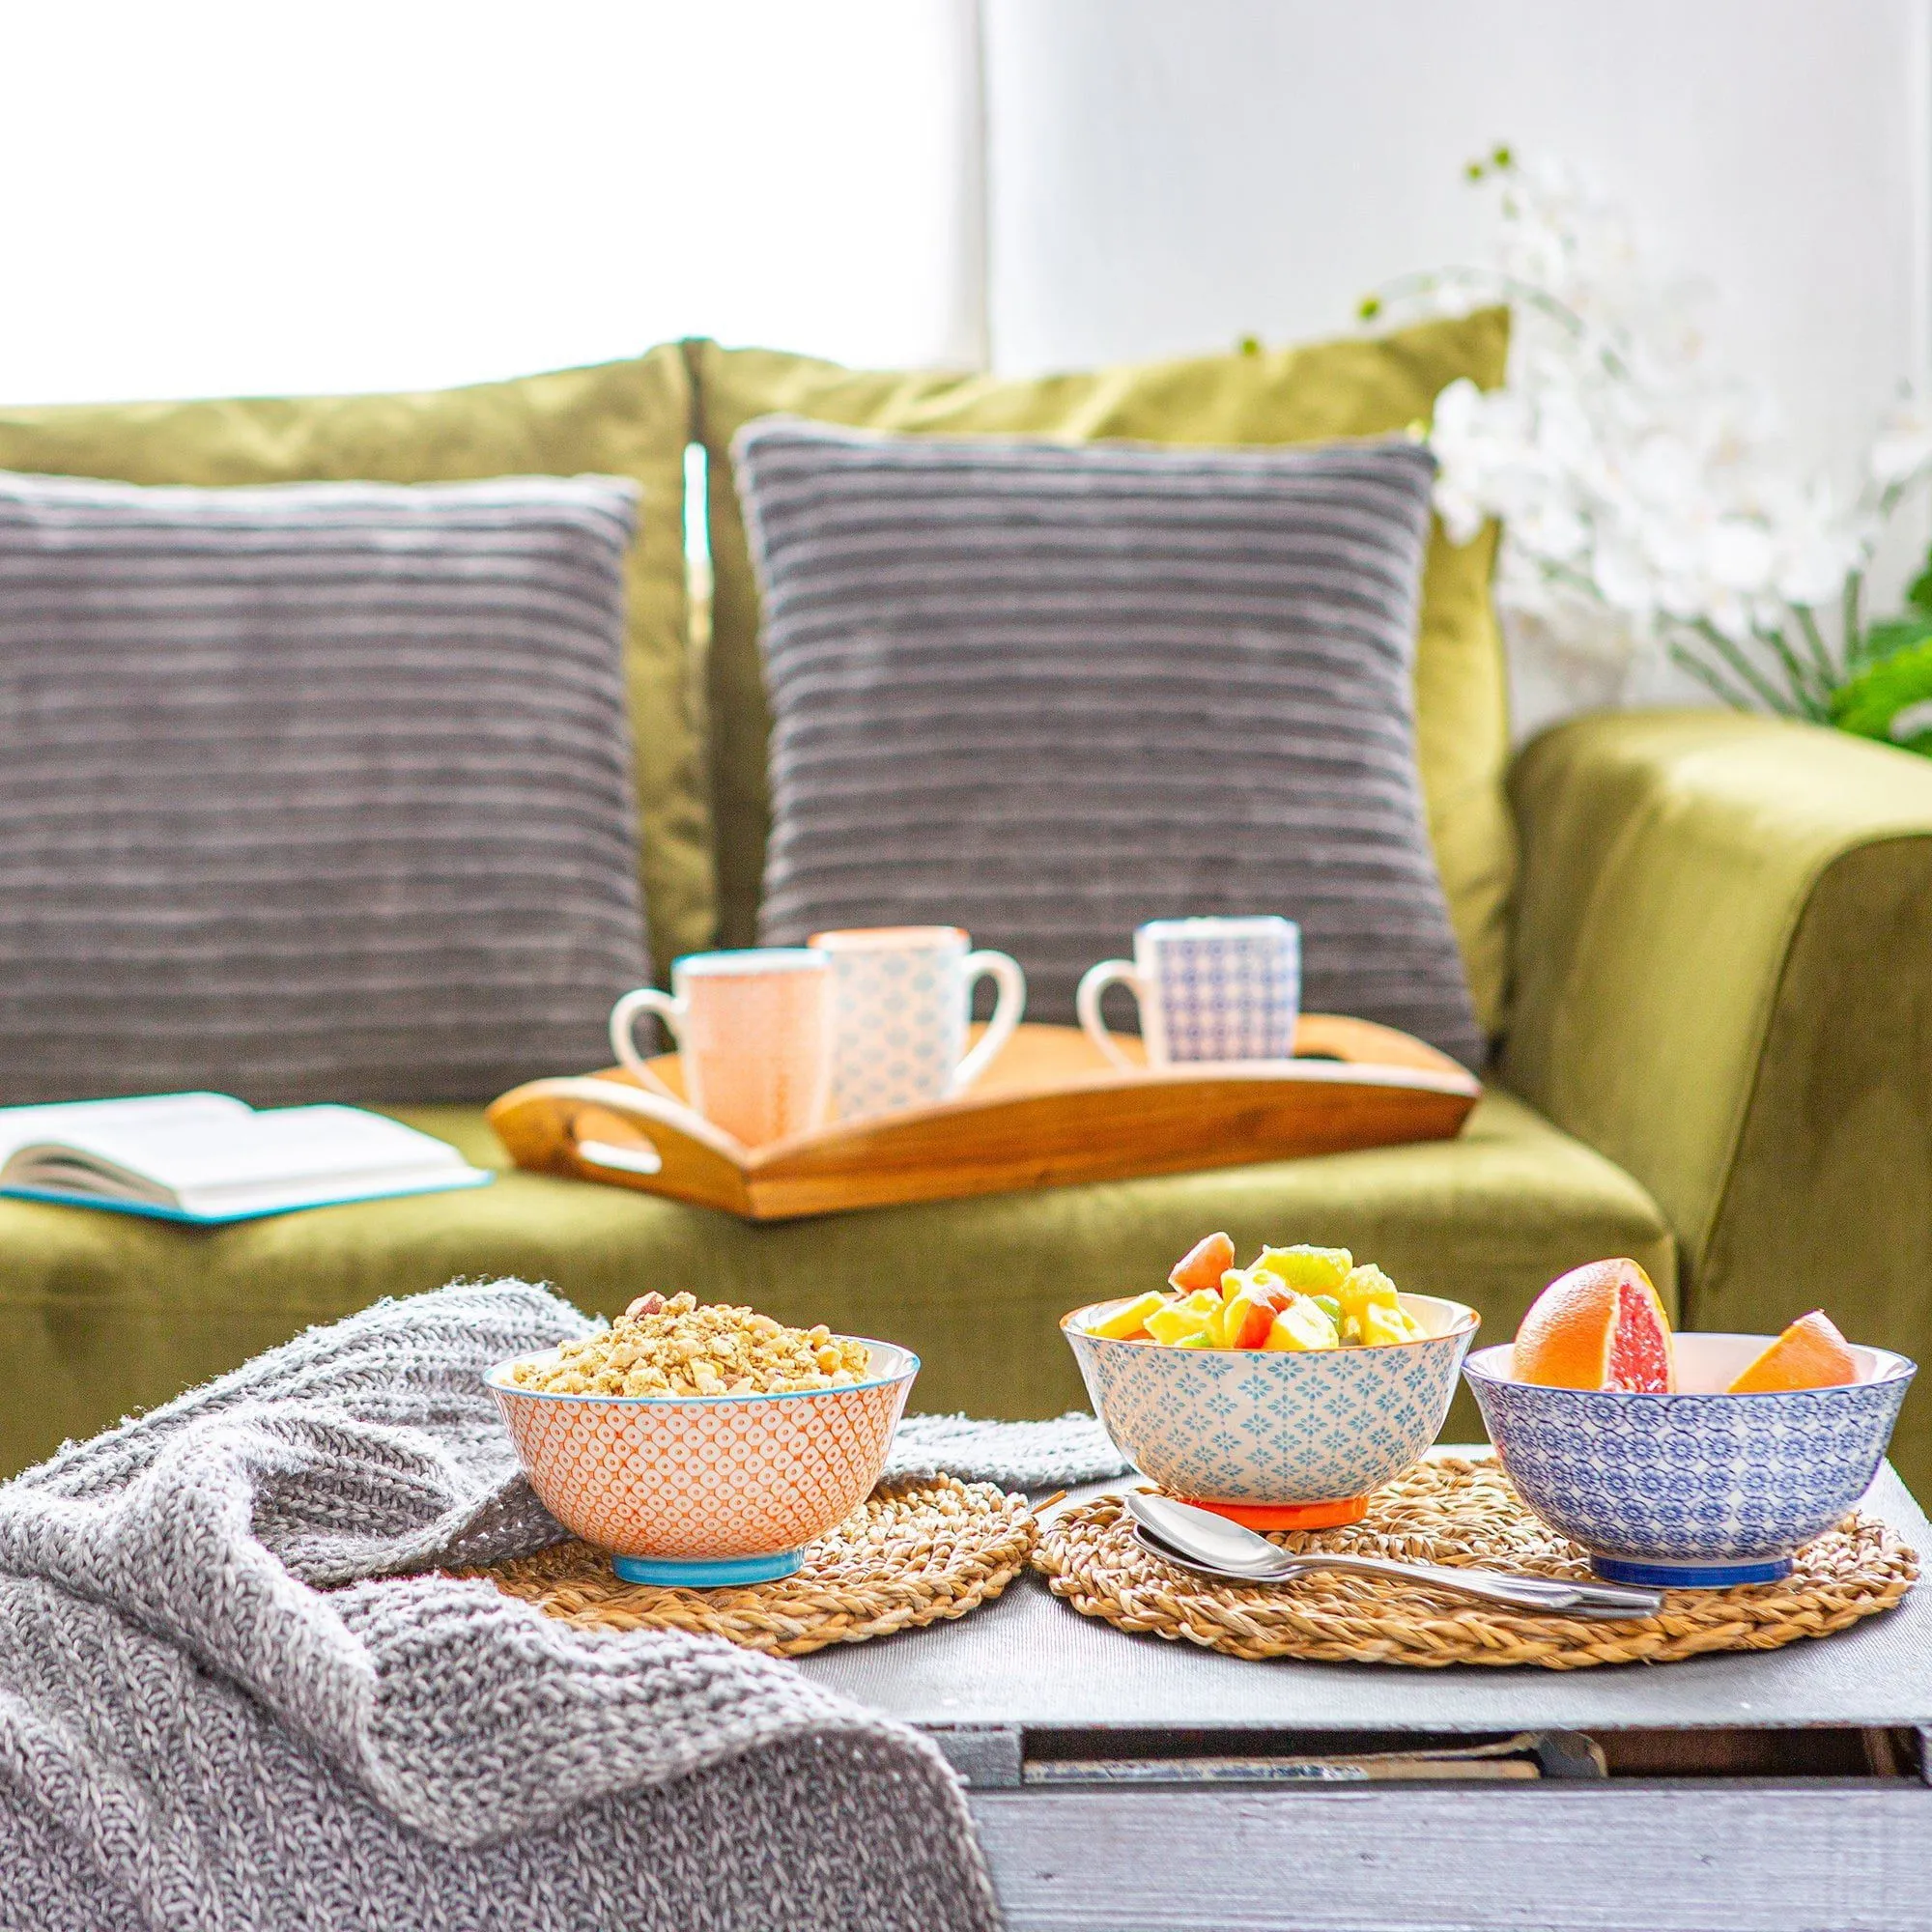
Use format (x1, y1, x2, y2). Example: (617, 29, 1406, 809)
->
(0, 1281, 997, 1932)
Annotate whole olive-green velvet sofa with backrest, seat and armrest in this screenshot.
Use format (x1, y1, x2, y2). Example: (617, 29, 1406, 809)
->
(0, 317, 1932, 1484)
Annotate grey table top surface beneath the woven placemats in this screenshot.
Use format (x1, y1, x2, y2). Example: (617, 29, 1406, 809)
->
(798, 1466, 1932, 1731)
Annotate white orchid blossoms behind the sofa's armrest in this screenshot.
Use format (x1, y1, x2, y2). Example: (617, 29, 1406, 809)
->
(1403, 145, 1932, 717)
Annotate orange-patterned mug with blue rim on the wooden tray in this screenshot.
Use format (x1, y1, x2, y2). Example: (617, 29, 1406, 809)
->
(611, 947, 833, 1148)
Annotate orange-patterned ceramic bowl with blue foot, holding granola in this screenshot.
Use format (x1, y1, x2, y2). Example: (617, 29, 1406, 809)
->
(485, 1337, 920, 1586)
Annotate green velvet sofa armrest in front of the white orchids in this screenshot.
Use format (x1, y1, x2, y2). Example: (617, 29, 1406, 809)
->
(1501, 713, 1932, 1360)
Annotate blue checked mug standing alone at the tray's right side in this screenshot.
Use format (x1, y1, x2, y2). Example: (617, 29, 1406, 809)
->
(1074, 914, 1302, 1066)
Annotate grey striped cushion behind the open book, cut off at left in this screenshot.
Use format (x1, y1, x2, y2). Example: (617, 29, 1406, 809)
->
(0, 475, 645, 1103)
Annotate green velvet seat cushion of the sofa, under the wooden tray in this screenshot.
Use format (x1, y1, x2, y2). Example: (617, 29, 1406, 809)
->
(0, 1092, 1675, 1474)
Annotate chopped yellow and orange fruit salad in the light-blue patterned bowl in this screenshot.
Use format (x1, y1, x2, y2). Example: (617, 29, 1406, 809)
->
(1088, 1235, 1424, 1352)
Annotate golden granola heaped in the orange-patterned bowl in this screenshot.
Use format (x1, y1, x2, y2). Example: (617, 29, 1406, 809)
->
(508, 1294, 871, 1399)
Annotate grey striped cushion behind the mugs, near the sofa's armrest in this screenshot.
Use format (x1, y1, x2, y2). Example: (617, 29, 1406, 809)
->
(734, 417, 1484, 1065)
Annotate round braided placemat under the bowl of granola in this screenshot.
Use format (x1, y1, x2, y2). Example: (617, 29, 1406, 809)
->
(468, 1476, 1036, 1658)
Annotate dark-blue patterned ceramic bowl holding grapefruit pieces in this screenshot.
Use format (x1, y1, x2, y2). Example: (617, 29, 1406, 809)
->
(1463, 1335, 1915, 1590)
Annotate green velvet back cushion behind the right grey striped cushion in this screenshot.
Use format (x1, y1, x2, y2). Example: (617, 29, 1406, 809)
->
(686, 309, 1515, 1032)
